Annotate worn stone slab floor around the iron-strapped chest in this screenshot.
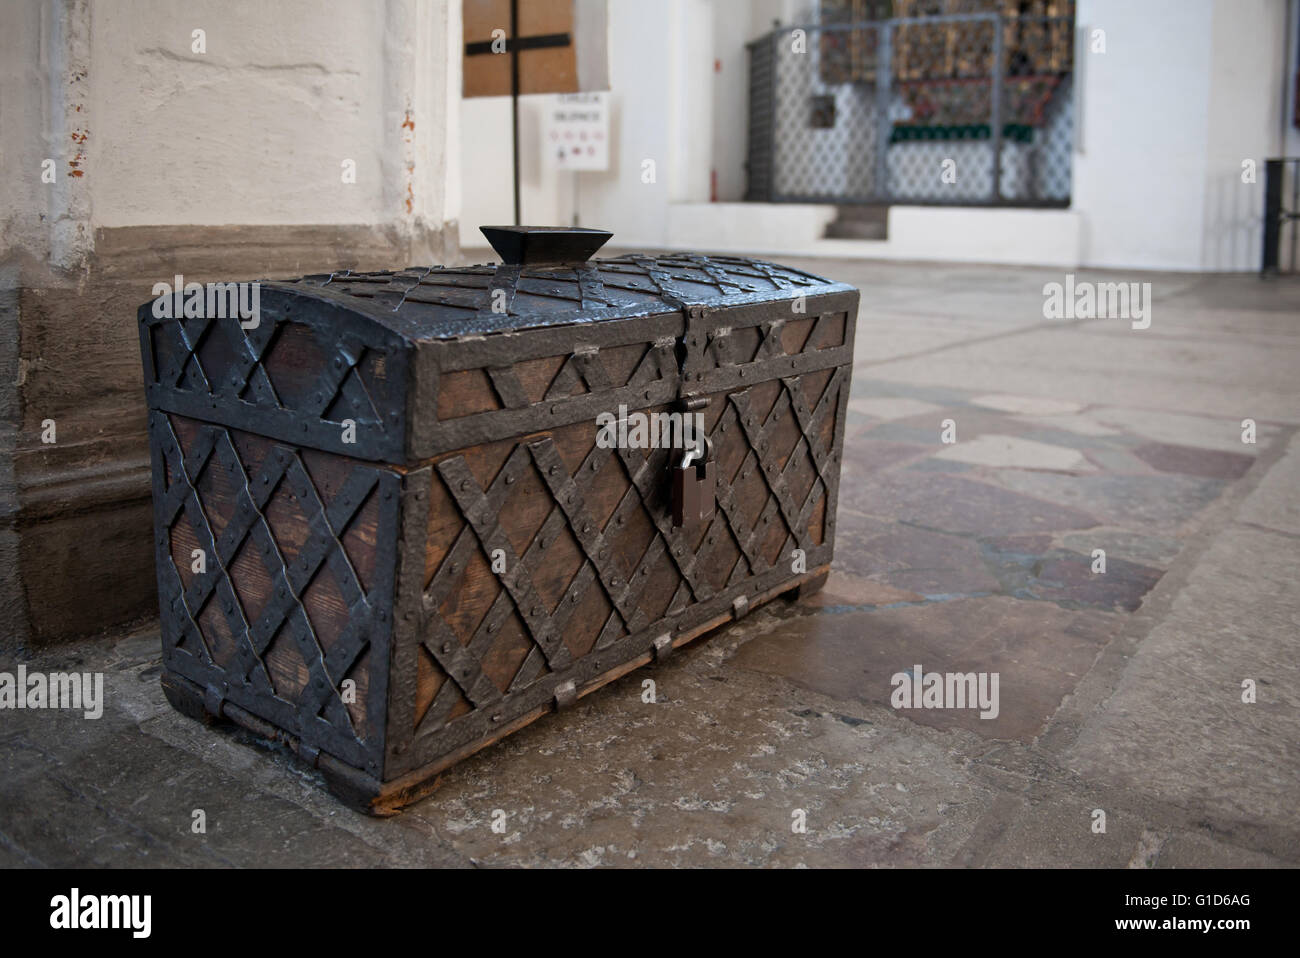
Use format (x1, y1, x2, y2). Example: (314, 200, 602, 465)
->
(0, 260, 1300, 867)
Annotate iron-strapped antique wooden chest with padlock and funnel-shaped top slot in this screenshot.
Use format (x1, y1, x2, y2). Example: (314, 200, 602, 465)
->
(139, 227, 858, 814)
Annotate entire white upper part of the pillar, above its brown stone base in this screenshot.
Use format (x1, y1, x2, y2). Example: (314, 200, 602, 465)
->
(0, 0, 460, 268)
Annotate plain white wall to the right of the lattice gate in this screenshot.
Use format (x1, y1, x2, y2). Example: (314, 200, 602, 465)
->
(1073, 0, 1286, 270)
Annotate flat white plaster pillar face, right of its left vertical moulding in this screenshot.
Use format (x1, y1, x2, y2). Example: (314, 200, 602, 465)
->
(90, 0, 459, 226)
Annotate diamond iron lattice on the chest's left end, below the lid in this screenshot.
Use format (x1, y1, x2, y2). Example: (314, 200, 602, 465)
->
(153, 413, 393, 764)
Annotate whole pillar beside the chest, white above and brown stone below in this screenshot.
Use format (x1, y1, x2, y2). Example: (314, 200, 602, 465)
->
(0, 0, 462, 650)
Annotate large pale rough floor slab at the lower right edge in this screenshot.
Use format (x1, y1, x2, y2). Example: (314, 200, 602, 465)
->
(1066, 526, 1300, 827)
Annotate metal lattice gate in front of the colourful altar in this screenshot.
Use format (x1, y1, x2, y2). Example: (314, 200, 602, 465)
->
(746, 13, 1074, 207)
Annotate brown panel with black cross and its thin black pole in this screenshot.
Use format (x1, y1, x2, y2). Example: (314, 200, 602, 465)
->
(464, 0, 577, 226)
